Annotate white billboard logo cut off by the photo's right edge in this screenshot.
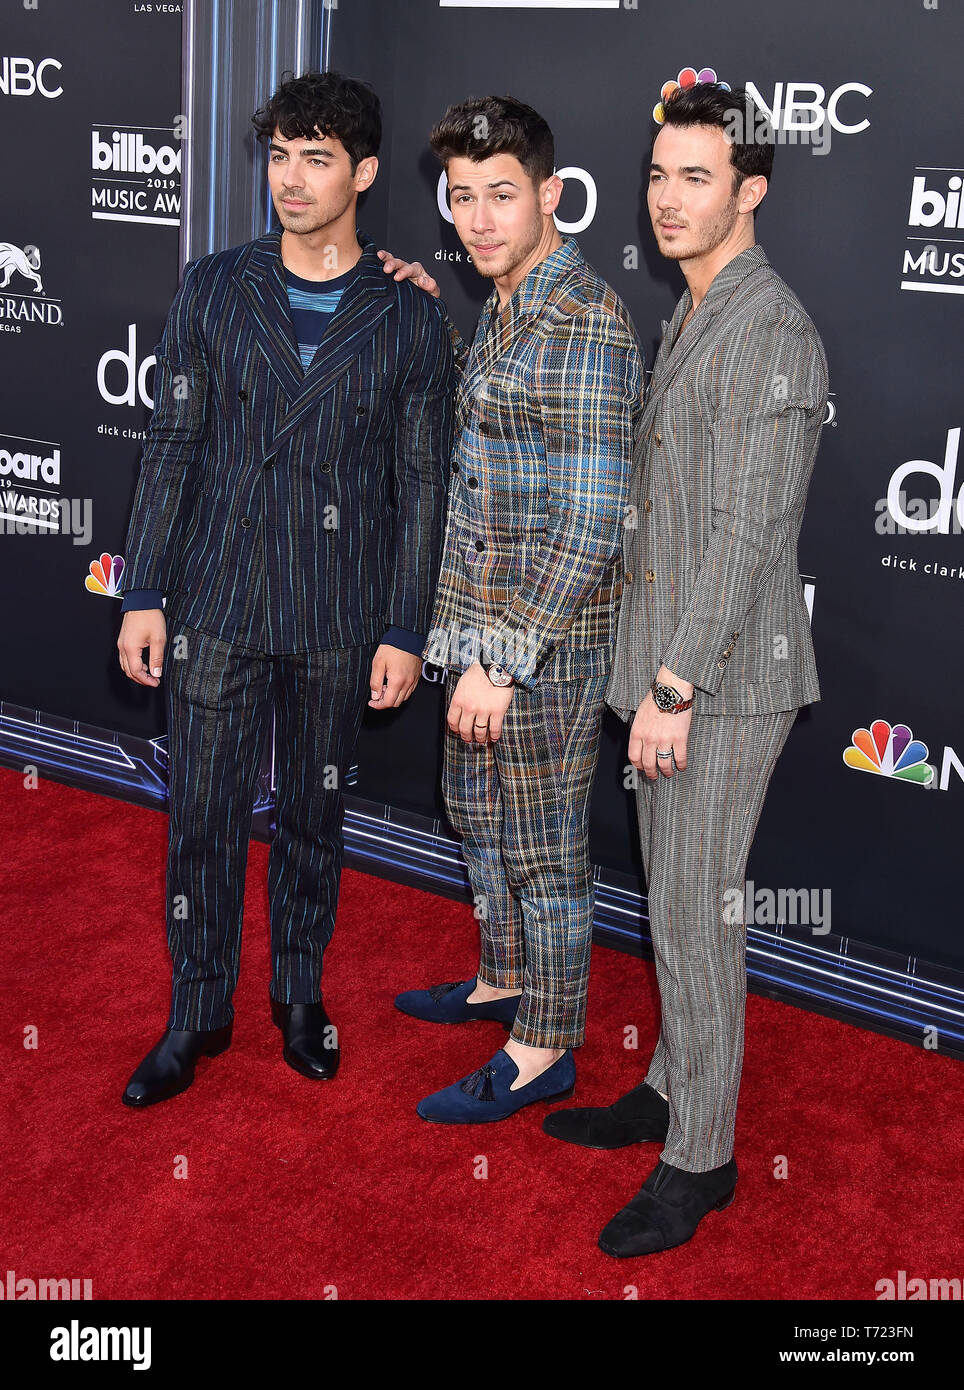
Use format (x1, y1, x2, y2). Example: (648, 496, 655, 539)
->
(900, 165, 964, 295)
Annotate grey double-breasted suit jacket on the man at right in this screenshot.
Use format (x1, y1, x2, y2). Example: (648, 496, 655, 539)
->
(607, 246, 828, 720)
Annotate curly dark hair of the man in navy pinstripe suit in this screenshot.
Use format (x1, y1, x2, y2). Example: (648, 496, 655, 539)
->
(251, 72, 382, 174)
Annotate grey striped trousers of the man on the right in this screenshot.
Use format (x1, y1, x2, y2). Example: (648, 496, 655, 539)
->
(636, 709, 797, 1173)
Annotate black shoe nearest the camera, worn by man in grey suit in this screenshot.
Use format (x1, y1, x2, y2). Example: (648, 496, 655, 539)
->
(599, 1158, 736, 1258)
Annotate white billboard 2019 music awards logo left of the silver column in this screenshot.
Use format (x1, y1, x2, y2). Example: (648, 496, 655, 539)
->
(90, 125, 181, 227)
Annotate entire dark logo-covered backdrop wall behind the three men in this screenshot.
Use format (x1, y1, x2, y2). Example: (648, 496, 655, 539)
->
(0, 0, 964, 1036)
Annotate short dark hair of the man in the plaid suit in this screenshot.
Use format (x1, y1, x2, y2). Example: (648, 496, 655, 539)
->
(429, 96, 556, 185)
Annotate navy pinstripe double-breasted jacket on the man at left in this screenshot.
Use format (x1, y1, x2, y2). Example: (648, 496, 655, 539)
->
(122, 228, 456, 653)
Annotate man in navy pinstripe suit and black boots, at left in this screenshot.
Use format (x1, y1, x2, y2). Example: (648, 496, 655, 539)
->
(118, 72, 454, 1106)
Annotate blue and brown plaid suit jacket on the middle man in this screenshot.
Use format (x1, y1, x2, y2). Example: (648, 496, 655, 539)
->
(424, 236, 642, 688)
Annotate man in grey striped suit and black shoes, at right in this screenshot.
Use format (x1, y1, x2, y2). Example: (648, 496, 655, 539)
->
(545, 83, 826, 1257)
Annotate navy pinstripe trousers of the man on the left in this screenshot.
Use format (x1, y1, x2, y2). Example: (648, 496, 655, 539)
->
(164, 614, 378, 1029)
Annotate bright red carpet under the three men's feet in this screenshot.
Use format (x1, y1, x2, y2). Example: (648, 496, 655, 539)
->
(0, 770, 964, 1300)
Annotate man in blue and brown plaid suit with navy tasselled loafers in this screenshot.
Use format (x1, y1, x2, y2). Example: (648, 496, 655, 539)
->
(385, 97, 642, 1123)
